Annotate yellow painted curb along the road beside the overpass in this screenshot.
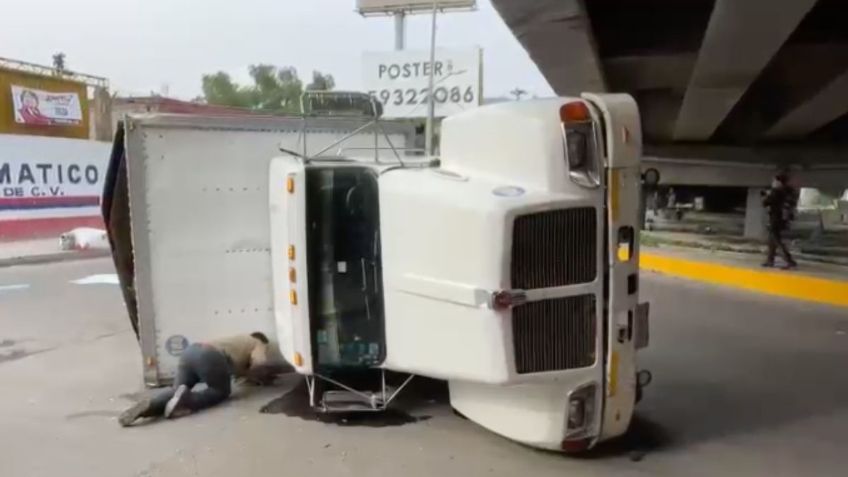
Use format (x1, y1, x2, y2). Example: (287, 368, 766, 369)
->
(639, 252, 848, 307)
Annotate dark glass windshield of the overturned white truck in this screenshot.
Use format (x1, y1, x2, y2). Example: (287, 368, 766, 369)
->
(306, 163, 385, 374)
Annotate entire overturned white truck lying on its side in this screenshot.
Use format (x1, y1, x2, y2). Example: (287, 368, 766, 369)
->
(103, 94, 649, 451)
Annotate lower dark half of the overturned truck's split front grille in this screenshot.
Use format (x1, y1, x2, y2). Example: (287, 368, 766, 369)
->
(512, 295, 597, 374)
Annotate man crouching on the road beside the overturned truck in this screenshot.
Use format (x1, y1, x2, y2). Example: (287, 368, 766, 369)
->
(118, 331, 281, 427)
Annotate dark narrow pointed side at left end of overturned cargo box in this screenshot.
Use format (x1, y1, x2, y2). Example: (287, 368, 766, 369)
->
(101, 121, 139, 339)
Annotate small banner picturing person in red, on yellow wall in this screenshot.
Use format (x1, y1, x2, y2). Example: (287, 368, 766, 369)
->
(11, 84, 82, 126)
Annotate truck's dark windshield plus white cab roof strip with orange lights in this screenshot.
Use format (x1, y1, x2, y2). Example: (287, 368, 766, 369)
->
(269, 157, 385, 374)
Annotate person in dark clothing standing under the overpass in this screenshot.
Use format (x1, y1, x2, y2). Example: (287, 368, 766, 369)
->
(763, 173, 798, 269)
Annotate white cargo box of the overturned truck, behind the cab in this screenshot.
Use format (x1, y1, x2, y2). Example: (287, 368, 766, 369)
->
(104, 109, 414, 385)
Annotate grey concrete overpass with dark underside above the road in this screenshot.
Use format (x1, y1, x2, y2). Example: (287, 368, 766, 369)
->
(492, 0, 848, 198)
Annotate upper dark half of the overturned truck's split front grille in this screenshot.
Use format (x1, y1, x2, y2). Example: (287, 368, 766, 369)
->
(510, 207, 597, 290)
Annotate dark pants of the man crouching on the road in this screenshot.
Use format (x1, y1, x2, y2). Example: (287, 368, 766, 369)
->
(142, 343, 232, 417)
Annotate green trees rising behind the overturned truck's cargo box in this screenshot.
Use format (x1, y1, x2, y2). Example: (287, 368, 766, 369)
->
(203, 64, 335, 114)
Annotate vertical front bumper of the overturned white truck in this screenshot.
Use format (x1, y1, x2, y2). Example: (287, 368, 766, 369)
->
(583, 94, 642, 436)
